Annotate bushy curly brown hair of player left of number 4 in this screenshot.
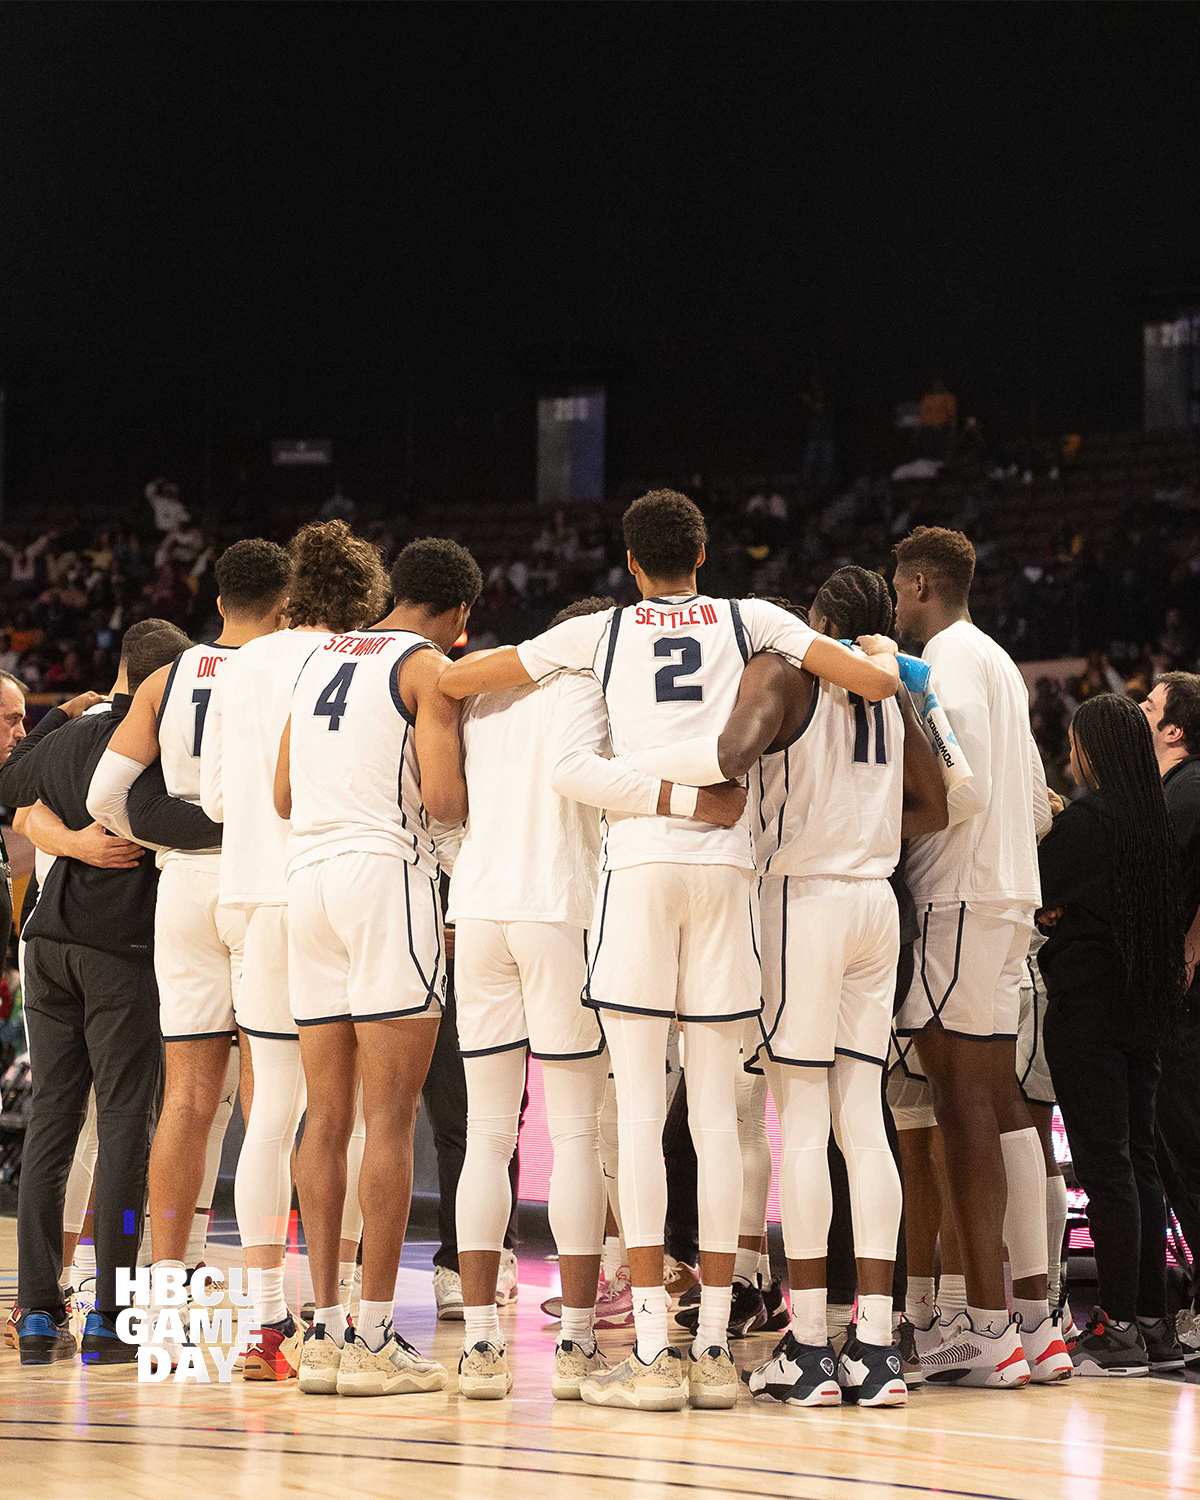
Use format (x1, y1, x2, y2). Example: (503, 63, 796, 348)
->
(288, 521, 387, 633)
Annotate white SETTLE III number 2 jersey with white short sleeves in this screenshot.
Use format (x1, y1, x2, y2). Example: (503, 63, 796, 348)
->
(518, 594, 816, 870)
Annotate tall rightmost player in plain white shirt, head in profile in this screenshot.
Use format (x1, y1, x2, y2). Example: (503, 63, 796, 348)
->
(896, 527, 1071, 1388)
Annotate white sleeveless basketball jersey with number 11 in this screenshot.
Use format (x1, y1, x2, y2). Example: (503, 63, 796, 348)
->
(750, 680, 905, 881)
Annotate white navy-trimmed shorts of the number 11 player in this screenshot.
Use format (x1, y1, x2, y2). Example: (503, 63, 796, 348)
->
(758, 875, 900, 1068)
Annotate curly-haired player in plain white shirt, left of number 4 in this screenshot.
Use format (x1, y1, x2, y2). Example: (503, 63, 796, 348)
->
(200, 521, 387, 1380)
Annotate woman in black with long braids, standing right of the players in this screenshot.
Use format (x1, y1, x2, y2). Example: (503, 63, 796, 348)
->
(1038, 693, 1187, 1376)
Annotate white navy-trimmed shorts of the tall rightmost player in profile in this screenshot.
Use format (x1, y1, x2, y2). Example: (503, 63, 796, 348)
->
(896, 902, 1031, 1041)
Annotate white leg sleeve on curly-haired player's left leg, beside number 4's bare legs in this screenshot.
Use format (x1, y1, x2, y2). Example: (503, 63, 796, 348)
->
(234, 1034, 306, 1247)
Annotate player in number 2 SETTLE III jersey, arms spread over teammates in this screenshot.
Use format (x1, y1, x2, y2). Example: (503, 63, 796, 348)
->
(443, 491, 897, 1410)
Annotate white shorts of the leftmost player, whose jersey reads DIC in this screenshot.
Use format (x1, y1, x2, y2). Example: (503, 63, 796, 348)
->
(155, 860, 246, 1041)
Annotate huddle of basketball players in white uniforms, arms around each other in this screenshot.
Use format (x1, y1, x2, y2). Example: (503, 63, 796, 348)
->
(9, 491, 1073, 1410)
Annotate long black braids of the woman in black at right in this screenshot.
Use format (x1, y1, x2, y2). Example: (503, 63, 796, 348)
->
(1071, 693, 1187, 1034)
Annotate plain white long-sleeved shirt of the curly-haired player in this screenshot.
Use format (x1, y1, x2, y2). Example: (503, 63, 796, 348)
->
(200, 630, 330, 909)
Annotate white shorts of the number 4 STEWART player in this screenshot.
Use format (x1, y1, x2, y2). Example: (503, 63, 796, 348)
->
(288, 852, 446, 1026)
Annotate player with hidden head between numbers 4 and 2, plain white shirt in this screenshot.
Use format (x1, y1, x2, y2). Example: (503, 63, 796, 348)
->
(450, 599, 746, 1400)
